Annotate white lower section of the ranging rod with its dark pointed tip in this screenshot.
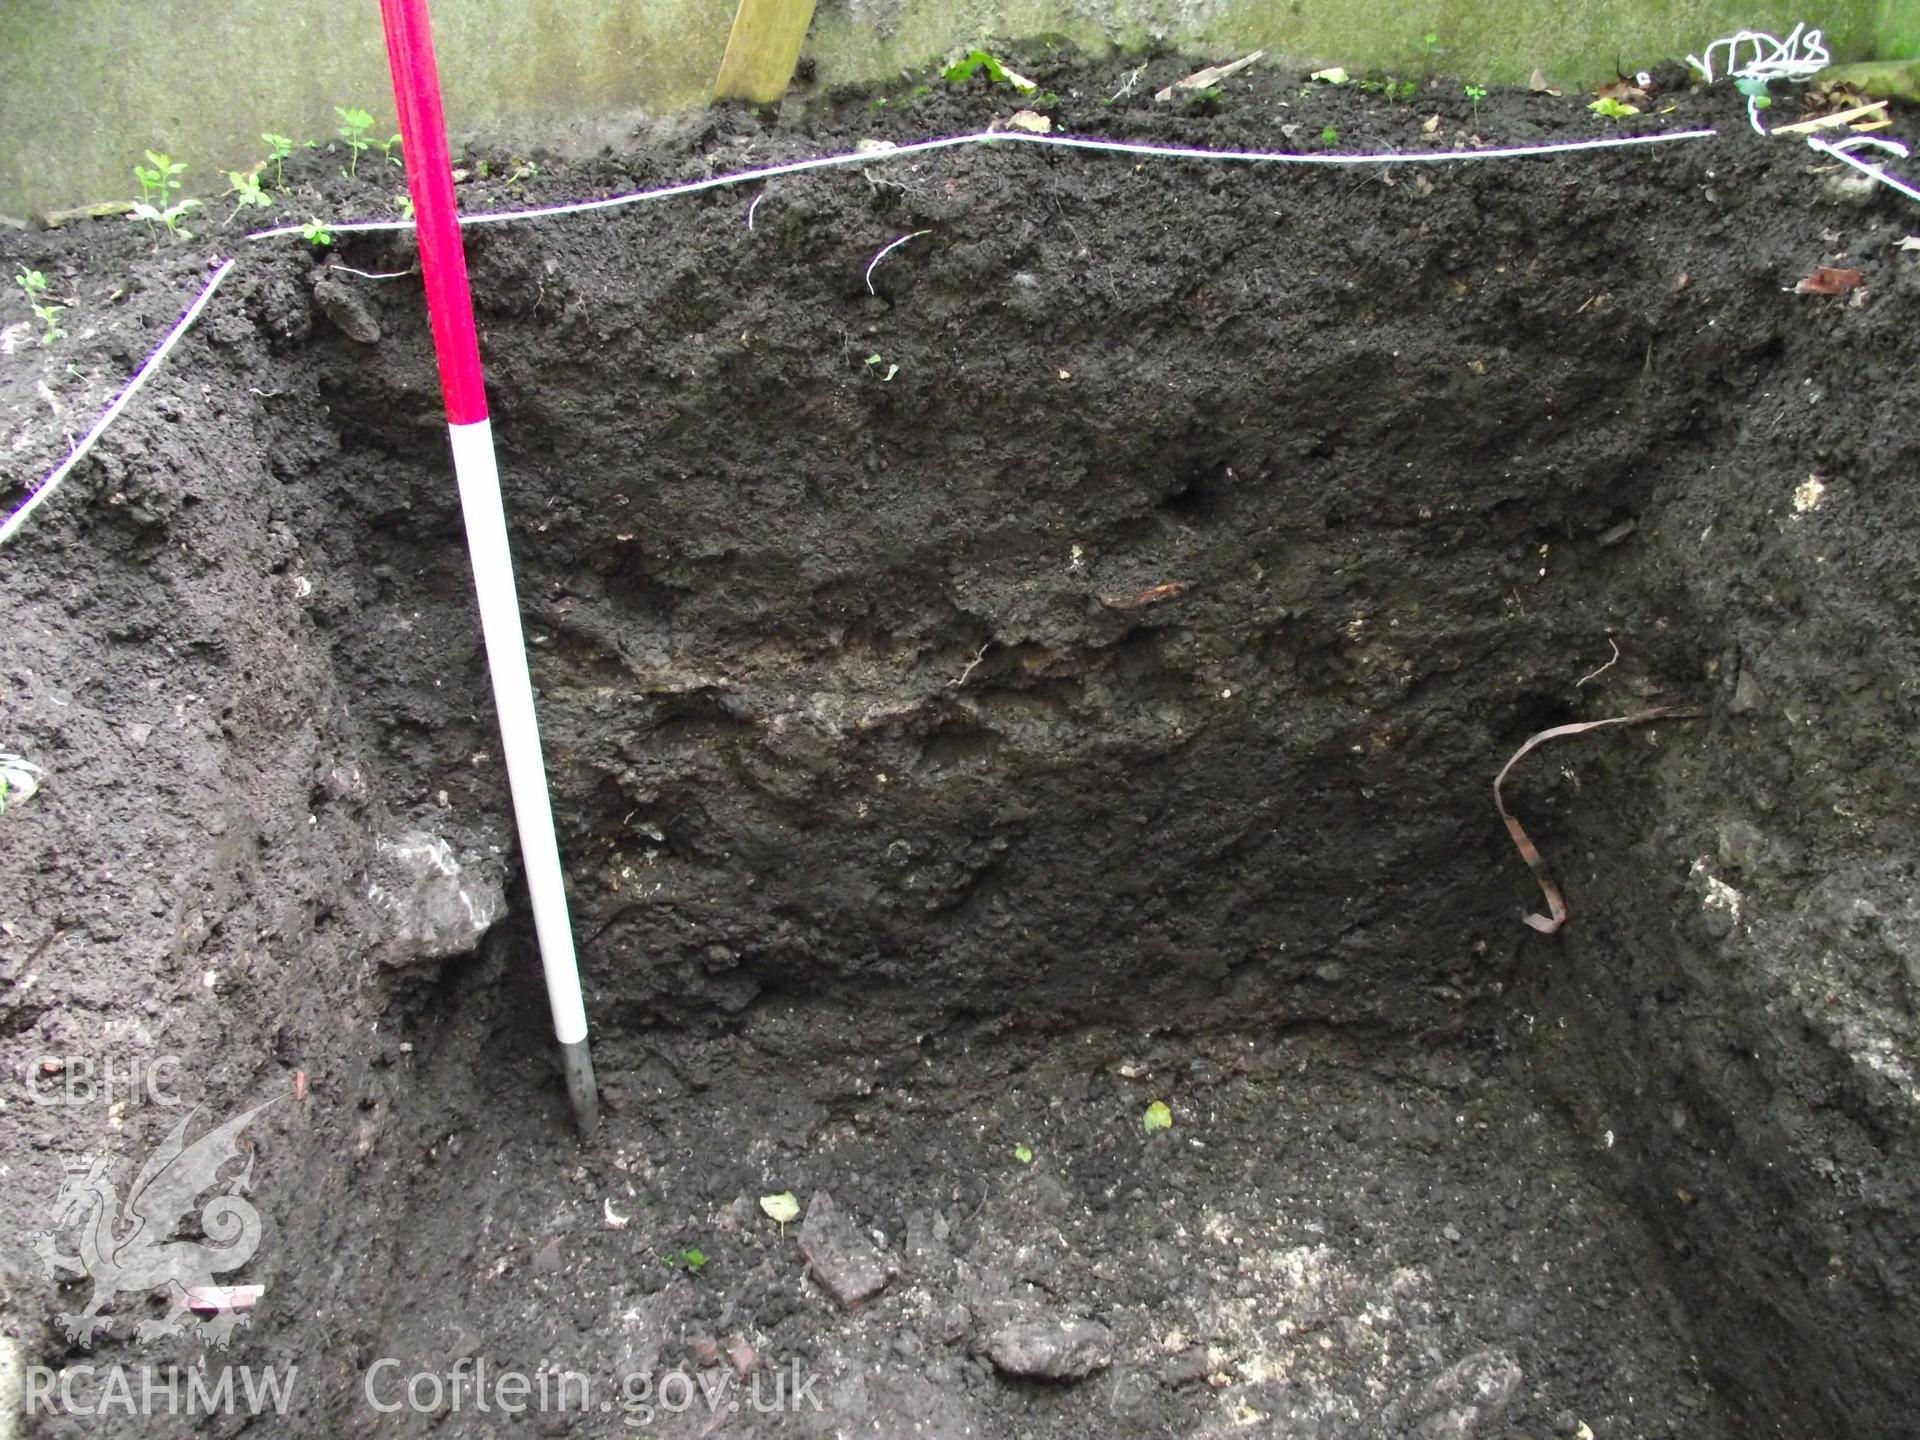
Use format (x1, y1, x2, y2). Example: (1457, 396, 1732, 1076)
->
(447, 420, 599, 1137)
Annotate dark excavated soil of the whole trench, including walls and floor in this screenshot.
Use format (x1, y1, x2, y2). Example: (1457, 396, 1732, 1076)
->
(0, 58, 1920, 1440)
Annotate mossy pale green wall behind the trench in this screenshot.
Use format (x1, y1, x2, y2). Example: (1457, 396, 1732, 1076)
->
(0, 0, 1889, 217)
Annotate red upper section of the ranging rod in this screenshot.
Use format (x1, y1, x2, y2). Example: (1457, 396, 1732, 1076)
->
(380, 0, 486, 424)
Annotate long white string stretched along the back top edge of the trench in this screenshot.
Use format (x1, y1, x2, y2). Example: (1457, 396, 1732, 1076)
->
(248, 129, 1718, 240)
